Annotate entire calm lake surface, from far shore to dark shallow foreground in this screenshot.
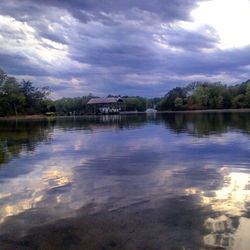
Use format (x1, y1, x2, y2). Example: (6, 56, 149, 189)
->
(0, 113, 250, 250)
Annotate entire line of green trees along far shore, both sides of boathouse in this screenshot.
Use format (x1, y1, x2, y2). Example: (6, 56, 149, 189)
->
(0, 69, 250, 116)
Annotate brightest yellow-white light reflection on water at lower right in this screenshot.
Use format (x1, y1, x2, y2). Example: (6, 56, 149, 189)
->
(186, 167, 250, 250)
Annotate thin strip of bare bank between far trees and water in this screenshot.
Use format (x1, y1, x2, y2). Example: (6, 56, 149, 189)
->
(0, 109, 250, 121)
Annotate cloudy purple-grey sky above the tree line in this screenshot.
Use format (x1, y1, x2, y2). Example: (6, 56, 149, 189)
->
(0, 0, 250, 98)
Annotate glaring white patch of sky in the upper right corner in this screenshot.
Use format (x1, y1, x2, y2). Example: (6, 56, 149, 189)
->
(188, 0, 250, 49)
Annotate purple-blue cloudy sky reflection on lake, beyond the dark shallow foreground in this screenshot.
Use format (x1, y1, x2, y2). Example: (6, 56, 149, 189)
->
(0, 114, 250, 249)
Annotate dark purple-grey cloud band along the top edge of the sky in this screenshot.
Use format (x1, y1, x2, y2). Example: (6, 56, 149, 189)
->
(33, 0, 197, 22)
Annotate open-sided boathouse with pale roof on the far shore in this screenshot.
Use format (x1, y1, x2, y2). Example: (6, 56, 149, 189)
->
(87, 97, 124, 114)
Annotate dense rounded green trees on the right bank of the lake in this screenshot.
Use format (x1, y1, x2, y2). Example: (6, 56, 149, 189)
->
(158, 80, 250, 110)
